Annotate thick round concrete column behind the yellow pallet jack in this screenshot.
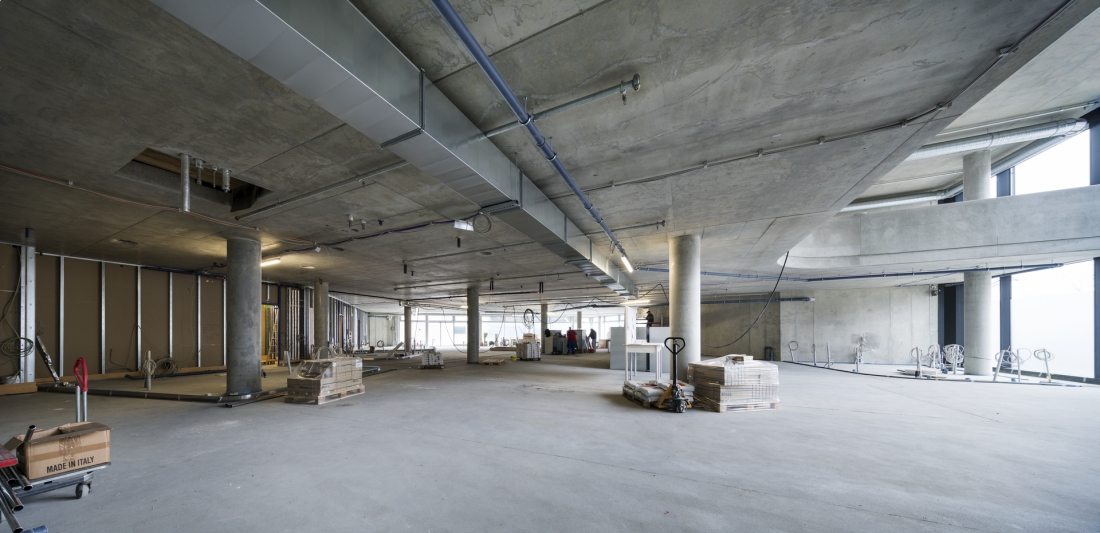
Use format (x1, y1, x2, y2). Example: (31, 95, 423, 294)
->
(664, 234, 703, 377)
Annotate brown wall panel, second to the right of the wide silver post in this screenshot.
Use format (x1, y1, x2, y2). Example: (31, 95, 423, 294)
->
(65, 258, 102, 374)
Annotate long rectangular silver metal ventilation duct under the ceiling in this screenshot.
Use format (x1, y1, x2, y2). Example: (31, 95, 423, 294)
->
(153, 0, 634, 296)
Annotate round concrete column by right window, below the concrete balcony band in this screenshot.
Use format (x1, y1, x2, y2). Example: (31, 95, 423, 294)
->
(963, 273, 998, 376)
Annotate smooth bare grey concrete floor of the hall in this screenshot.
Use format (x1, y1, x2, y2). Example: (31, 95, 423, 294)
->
(0, 354, 1100, 533)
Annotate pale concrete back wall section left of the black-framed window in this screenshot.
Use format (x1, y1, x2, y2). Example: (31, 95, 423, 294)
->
(779, 286, 938, 363)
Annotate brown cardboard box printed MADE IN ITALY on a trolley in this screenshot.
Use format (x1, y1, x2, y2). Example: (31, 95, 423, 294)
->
(4, 422, 111, 480)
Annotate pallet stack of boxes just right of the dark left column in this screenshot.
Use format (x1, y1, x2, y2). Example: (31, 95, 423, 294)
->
(285, 357, 363, 404)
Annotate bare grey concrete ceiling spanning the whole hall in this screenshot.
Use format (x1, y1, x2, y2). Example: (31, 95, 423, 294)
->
(0, 0, 1100, 312)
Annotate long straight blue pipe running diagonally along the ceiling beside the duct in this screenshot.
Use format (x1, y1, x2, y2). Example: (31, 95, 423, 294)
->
(431, 0, 629, 262)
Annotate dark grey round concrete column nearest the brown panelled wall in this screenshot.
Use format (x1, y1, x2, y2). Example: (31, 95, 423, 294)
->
(226, 237, 263, 395)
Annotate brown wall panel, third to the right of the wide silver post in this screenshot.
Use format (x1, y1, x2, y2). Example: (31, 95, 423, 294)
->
(105, 263, 138, 373)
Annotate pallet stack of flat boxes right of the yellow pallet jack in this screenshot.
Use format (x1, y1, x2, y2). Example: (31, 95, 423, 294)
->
(688, 355, 779, 412)
